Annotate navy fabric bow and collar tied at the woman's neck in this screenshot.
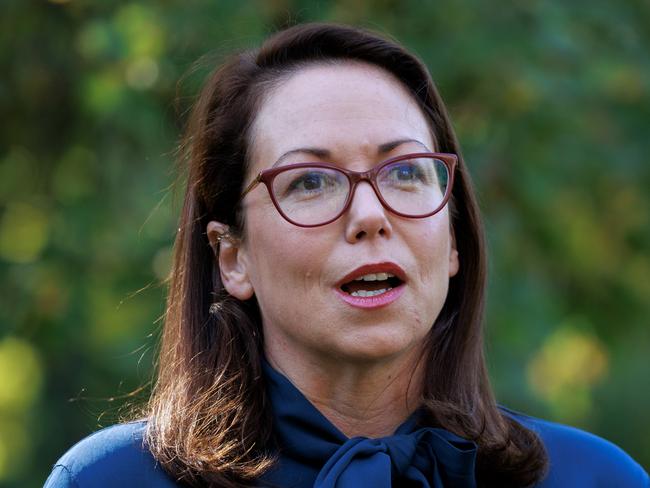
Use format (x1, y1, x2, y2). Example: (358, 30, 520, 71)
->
(264, 363, 478, 488)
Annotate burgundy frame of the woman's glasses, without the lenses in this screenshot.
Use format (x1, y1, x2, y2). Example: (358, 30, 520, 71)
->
(239, 152, 458, 227)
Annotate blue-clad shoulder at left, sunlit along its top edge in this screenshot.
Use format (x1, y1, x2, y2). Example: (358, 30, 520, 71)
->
(45, 421, 178, 488)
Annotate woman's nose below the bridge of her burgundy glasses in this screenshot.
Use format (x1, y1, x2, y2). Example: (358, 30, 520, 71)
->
(345, 181, 393, 244)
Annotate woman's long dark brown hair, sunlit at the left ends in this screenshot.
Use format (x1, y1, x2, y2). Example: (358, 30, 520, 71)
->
(146, 24, 547, 487)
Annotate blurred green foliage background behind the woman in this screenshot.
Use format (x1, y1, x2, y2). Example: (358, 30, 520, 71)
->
(0, 0, 650, 487)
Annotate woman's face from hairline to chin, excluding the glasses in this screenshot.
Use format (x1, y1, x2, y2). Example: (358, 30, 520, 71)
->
(216, 63, 458, 362)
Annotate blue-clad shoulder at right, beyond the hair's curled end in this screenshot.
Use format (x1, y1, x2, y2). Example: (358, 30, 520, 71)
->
(499, 406, 650, 488)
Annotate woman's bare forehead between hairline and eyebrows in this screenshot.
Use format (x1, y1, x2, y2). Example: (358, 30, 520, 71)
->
(251, 62, 435, 170)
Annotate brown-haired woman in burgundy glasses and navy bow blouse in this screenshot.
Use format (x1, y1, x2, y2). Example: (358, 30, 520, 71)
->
(46, 24, 650, 487)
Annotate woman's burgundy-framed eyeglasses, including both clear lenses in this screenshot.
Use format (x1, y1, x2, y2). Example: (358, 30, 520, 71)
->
(241, 153, 458, 227)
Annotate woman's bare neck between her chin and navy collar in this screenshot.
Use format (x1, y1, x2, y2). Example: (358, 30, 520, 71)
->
(266, 350, 423, 438)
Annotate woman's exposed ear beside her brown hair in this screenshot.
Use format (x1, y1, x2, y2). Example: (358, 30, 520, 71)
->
(207, 220, 255, 300)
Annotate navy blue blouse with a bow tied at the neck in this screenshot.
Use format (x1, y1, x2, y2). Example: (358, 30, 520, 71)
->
(45, 364, 650, 488)
